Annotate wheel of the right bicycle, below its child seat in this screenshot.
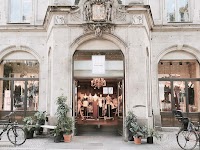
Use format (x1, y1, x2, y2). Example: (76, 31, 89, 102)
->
(176, 130, 198, 150)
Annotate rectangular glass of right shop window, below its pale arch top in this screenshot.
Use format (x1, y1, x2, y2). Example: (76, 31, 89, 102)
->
(158, 61, 200, 112)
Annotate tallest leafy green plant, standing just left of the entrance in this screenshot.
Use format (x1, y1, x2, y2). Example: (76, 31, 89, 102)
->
(54, 95, 73, 141)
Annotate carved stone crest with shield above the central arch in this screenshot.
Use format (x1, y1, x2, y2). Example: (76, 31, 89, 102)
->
(83, 0, 113, 36)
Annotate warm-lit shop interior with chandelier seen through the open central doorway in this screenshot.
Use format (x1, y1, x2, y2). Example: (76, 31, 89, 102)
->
(75, 78, 123, 134)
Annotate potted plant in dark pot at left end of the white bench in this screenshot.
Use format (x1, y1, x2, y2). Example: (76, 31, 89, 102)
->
(34, 111, 46, 135)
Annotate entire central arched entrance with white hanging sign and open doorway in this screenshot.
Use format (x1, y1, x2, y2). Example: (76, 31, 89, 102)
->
(73, 40, 124, 135)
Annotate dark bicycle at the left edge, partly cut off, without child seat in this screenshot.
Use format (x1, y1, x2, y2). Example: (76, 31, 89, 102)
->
(0, 112, 26, 146)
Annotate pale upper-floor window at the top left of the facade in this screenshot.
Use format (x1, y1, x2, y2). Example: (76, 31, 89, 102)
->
(9, 0, 32, 23)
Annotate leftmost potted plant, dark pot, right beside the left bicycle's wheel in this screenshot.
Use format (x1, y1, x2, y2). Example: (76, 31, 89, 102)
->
(23, 116, 35, 139)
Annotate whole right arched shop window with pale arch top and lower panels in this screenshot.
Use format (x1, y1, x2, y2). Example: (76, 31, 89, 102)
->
(158, 51, 200, 126)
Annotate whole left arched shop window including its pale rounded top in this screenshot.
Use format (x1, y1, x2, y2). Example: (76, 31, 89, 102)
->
(0, 47, 39, 123)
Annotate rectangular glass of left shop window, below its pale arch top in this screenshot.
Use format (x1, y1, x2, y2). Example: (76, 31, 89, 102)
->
(0, 61, 39, 111)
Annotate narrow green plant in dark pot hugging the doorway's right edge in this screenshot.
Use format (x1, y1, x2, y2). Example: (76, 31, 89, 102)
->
(126, 111, 137, 141)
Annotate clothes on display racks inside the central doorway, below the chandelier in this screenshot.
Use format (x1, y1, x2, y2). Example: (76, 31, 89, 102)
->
(75, 79, 123, 124)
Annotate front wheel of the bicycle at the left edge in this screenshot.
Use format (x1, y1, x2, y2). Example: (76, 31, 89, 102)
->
(7, 126, 26, 146)
